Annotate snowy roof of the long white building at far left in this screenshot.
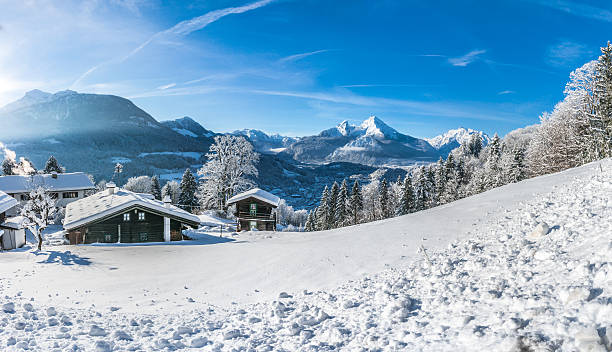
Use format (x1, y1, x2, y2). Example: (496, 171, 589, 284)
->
(0, 172, 95, 193)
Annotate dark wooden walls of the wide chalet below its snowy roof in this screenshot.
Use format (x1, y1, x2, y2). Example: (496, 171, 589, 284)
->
(68, 207, 194, 244)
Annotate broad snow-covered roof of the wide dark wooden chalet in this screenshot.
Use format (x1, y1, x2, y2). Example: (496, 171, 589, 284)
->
(64, 188, 200, 230)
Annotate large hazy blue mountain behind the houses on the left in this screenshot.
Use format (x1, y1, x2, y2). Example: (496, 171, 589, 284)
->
(0, 90, 211, 181)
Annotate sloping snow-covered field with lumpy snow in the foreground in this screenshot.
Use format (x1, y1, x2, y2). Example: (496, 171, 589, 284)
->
(0, 159, 612, 351)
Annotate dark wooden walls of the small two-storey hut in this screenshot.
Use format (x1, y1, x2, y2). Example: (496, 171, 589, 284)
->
(234, 197, 276, 231)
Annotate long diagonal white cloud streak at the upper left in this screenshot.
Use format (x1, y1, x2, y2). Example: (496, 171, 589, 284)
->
(71, 0, 275, 87)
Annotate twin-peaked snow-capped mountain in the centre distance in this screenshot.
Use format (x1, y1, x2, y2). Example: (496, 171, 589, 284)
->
(285, 116, 438, 165)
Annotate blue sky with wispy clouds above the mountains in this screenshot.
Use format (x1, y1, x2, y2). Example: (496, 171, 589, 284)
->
(0, 0, 612, 137)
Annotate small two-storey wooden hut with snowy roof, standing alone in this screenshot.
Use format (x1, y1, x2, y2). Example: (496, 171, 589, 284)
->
(227, 188, 280, 231)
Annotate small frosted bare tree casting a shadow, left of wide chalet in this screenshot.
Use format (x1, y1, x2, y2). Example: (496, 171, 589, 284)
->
(21, 186, 57, 251)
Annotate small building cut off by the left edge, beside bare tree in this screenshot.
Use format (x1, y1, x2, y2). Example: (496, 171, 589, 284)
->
(0, 191, 25, 250)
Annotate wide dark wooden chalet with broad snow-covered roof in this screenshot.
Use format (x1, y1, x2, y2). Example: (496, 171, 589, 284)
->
(64, 182, 200, 244)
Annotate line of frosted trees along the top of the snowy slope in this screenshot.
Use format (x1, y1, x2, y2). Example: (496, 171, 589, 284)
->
(305, 42, 612, 231)
